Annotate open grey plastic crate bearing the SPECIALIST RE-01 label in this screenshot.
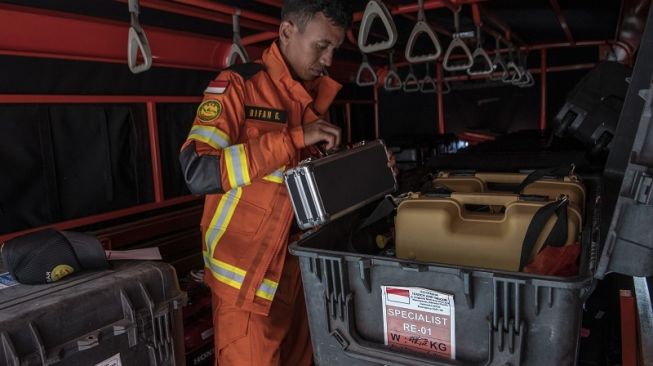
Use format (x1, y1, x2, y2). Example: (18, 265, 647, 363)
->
(290, 179, 600, 366)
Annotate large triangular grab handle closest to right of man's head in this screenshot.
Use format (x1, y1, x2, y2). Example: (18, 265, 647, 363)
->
(358, 0, 399, 53)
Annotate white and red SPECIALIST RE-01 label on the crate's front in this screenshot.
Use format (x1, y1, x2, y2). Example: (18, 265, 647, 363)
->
(381, 286, 456, 359)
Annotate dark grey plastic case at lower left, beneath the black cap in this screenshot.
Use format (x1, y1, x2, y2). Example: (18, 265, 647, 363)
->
(0, 262, 185, 366)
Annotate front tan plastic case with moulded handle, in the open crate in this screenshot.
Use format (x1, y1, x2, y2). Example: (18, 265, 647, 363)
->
(395, 193, 582, 271)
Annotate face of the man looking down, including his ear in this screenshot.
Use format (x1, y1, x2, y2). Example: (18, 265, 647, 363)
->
(280, 13, 345, 81)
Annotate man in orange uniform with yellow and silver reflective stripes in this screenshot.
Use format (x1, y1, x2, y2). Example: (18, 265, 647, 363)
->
(180, 0, 352, 366)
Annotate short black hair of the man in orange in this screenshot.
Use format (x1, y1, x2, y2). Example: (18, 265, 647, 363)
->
(281, 0, 352, 31)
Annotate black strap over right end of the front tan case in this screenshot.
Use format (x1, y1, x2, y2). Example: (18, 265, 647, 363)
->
(519, 195, 569, 272)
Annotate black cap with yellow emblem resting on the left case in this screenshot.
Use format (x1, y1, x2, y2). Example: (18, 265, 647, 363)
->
(0, 229, 109, 285)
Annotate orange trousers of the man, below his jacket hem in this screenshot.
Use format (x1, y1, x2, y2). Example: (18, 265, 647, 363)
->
(213, 256, 313, 366)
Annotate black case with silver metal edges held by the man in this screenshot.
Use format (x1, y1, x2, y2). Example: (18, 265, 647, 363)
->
(284, 140, 397, 229)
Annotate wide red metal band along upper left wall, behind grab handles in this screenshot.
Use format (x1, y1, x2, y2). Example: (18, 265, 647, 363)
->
(0, 4, 262, 71)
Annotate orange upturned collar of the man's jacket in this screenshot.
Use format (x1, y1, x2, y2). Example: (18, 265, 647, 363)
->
(262, 41, 342, 114)
